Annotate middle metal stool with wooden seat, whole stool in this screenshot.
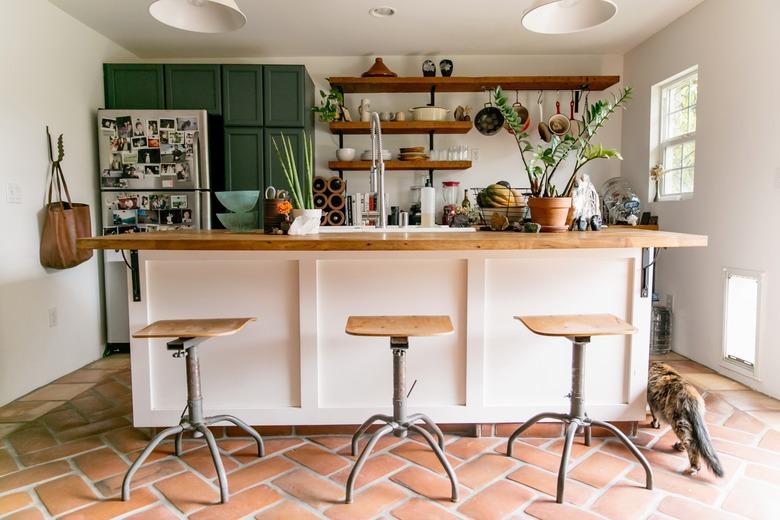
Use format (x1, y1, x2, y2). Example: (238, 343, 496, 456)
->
(345, 316, 458, 504)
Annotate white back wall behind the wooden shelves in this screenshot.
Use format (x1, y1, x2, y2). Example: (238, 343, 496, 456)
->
(143, 55, 623, 213)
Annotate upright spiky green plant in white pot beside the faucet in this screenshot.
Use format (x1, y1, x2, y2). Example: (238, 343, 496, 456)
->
(271, 132, 322, 235)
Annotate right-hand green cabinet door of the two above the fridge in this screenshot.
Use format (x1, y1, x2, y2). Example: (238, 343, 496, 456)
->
(165, 64, 222, 115)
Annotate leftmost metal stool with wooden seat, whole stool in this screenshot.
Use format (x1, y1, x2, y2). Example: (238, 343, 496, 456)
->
(122, 318, 265, 504)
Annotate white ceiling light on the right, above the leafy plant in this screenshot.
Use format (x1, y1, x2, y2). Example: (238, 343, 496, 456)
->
(522, 0, 617, 34)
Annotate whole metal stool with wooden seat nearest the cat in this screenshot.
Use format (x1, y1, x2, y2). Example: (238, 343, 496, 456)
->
(506, 314, 653, 504)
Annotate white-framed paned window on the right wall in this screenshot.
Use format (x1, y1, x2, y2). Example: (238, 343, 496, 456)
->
(652, 68, 698, 200)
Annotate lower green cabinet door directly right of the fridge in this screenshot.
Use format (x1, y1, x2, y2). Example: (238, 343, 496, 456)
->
(225, 127, 263, 191)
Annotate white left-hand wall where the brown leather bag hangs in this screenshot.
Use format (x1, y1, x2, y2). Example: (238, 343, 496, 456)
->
(0, 0, 132, 405)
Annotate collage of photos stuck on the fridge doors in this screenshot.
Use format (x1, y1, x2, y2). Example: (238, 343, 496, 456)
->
(100, 116, 198, 235)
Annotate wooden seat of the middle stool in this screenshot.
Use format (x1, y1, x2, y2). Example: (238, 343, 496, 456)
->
(345, 316, 455, 338)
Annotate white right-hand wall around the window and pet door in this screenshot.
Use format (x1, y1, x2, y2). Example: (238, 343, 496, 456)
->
(622, 0, 780, 397)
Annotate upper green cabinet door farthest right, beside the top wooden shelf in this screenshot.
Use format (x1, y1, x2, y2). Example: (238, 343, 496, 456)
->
(263, 65, 314, 128)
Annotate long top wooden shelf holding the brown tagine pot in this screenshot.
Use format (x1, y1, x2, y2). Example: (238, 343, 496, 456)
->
(328, 76, 620, 94)
